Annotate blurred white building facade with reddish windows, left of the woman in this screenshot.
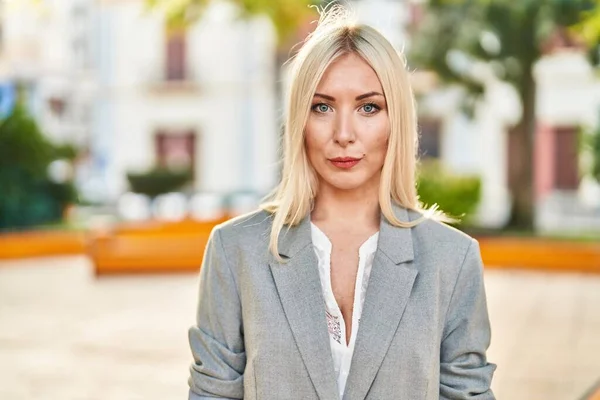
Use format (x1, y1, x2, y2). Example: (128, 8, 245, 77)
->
(0, 0, 280, 203)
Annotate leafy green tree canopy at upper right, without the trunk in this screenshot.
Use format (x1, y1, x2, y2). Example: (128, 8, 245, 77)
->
(411, 0, 600, 97)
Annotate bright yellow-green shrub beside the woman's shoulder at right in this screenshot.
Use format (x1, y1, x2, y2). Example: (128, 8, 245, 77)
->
(417, 161, 481, 223)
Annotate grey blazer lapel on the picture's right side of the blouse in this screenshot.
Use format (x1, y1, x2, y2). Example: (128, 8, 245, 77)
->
(344, 207, 417, 400)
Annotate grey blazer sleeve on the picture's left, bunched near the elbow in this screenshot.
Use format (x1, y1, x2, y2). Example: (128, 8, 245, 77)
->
(188, 228, 246, 400)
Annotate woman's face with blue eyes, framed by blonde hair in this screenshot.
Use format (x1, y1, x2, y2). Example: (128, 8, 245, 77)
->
(305, 54, 390, 190)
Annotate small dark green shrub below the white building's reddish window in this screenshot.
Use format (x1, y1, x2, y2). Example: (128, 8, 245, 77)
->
(127, 168, 193, 198)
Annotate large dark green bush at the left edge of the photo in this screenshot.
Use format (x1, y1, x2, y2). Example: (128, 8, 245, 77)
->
(0, 104, 77, 230)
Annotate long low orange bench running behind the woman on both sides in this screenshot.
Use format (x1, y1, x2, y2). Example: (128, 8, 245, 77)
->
(0, 218, 600, 274)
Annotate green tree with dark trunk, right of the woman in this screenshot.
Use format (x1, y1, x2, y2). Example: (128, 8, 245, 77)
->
(410, 0, 600, 229)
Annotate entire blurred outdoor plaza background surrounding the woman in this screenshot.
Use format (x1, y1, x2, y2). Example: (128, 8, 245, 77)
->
(0, 0, 600, 400)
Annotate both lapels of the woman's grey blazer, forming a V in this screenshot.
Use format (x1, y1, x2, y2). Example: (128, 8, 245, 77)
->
(269, 206, 417, 400)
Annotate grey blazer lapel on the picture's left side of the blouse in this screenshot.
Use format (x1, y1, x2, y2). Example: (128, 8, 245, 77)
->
(269, 215, 339, 400)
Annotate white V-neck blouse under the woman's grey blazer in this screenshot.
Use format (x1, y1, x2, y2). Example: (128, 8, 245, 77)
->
(311, 223, 379, 398)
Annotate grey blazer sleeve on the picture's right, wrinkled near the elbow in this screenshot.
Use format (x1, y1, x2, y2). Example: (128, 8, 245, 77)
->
(440, 239, 496, 400)
